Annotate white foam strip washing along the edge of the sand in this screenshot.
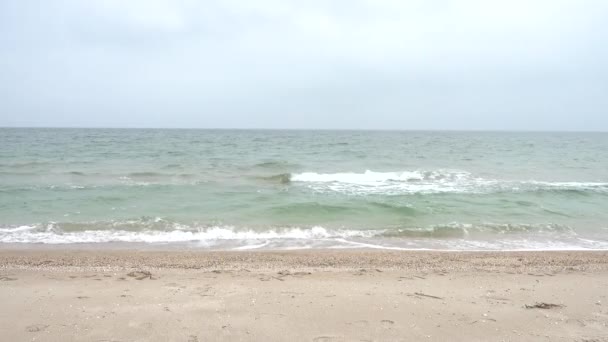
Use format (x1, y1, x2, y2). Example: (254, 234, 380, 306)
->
(0, 223, 608, 251)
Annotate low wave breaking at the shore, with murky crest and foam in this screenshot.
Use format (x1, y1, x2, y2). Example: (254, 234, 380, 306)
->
(0, 217, 608, 250)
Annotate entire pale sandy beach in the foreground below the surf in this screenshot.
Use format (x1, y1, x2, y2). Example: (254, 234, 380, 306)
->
(0, 247, 608, 342)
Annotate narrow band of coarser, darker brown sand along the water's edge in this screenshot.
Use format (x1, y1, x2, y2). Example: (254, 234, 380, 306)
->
(0, 246, 608, 272)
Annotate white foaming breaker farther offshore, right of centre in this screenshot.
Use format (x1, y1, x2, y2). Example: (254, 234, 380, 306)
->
(289, 170, 608, 194)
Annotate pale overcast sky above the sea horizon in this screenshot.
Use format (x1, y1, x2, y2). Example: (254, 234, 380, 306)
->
(0, 0, 608, 131)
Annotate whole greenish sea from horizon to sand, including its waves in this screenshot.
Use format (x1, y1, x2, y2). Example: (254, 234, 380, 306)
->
(0, 128, 608, 250)
